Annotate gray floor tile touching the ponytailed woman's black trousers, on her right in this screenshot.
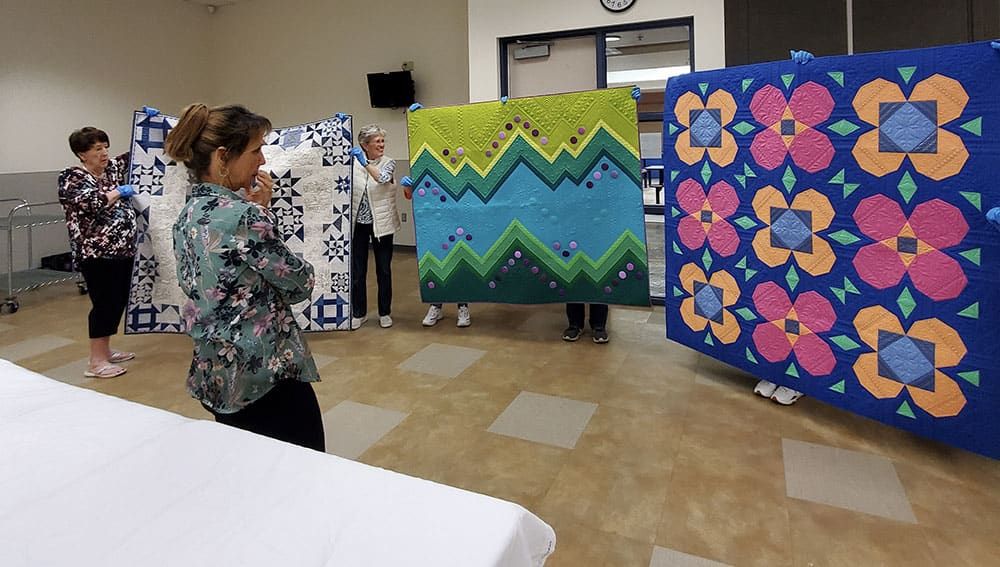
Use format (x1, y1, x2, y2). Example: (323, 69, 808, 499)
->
(323, 400, 409, 459)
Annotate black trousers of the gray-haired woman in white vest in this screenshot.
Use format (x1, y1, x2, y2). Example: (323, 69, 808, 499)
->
(351, 223, 392, 317)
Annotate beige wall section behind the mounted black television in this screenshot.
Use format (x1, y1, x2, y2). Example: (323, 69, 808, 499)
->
(213, 0, 469, 245)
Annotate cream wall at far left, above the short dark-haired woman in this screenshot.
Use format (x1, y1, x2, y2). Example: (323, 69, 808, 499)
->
(0, 0, 212, 174)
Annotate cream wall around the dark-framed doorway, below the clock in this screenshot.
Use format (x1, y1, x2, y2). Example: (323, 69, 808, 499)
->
(468, 0, 726, 102)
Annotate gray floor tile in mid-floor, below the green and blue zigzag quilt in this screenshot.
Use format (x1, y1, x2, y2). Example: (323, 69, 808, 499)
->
(489, 392, 597, 449)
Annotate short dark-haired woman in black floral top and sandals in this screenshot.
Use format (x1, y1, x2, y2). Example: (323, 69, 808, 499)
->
(59, 120, 149, 378)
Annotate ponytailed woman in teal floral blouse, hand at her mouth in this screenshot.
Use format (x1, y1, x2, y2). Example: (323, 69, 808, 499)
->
(165, 104, 325, 451)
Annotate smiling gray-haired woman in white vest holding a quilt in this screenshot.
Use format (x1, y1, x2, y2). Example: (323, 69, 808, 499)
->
(351, 124, 399, 329)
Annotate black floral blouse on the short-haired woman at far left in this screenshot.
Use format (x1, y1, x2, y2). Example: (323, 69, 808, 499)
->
(59, 152, 136, 263)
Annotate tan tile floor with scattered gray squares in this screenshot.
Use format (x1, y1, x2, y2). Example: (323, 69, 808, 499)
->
(0, 252, 1000, 567)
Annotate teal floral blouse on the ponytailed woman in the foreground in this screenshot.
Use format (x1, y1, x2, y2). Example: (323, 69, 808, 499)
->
(173, 183, 319, 413)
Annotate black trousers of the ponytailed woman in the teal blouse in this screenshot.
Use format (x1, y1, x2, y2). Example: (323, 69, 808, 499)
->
(205, 380, 326, 452)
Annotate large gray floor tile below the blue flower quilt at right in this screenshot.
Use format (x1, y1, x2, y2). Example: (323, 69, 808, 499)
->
(781, 439, 917, 524)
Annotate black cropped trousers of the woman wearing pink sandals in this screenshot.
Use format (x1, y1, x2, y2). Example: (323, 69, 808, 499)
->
(80, 258, 134, 339)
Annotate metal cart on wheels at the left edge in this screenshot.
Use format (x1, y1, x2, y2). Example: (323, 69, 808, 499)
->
(0, 199, 87, 313)
